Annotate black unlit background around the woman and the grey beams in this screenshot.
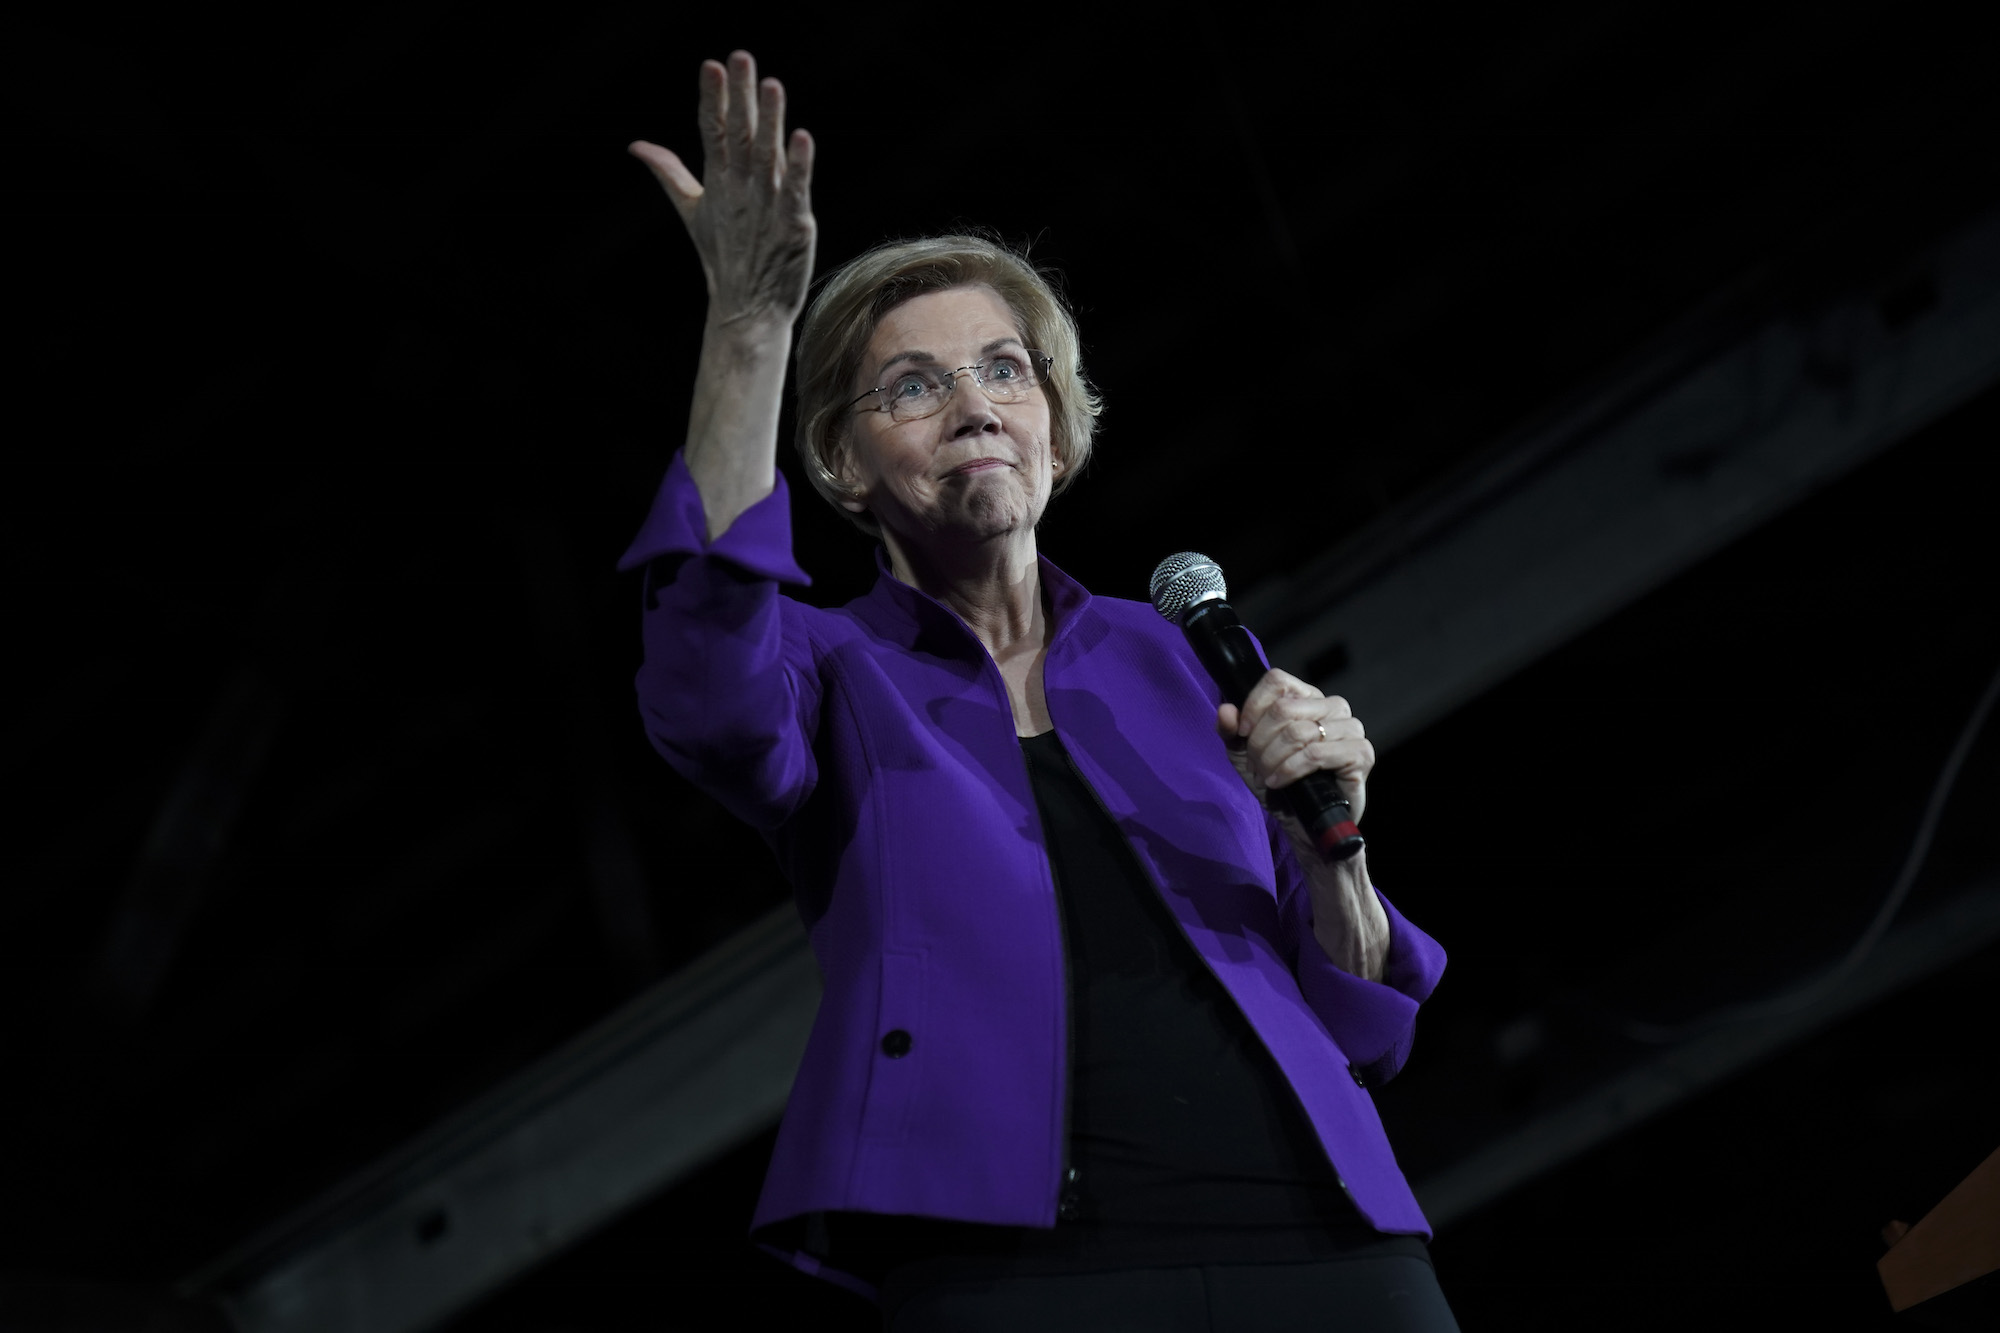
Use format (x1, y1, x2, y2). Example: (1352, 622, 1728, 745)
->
(0, 2, 2000, 1333)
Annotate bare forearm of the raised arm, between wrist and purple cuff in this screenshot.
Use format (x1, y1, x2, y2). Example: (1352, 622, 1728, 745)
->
(686, 314, 792, 540)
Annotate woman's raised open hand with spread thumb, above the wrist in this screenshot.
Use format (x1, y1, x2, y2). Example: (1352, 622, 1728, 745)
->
(628, 50, 818, 328)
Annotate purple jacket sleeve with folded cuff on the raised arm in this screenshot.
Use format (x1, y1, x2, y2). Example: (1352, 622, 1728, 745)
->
(618, 452, 820, 833)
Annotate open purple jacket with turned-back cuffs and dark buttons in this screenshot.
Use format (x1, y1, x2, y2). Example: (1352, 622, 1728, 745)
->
(620, 454, 1444, 1277)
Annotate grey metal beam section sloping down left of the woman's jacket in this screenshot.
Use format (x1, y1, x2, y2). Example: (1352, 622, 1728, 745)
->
(180, 905, 820, 1333)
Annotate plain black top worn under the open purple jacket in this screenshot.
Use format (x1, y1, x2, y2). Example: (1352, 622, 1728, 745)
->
(826, 731, 1422, 1281)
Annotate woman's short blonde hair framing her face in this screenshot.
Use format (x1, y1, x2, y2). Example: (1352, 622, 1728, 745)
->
(796, 234, 1104, 536)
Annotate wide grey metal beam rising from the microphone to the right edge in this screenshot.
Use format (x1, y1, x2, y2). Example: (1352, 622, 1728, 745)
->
(1238, 214, 2000, 749)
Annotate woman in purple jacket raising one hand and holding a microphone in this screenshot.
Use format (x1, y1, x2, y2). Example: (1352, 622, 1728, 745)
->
(624, 52, 1456, 1333)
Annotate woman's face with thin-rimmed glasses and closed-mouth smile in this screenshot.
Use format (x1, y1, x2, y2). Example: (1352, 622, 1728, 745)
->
(840, 286, 1058, 548)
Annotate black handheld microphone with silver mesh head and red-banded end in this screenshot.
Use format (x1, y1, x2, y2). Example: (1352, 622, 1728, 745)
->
(1150, 550, 1362, 861)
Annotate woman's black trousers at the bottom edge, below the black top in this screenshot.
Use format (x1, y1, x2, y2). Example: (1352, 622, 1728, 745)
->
(882, 1255, 1458, 1333)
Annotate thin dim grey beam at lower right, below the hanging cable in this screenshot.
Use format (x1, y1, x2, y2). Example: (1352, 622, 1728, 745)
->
(1414, 885, 2000, 1229)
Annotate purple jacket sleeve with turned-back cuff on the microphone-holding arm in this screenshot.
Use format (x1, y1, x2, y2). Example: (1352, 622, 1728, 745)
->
(1266, 819, 1444, 1087)
